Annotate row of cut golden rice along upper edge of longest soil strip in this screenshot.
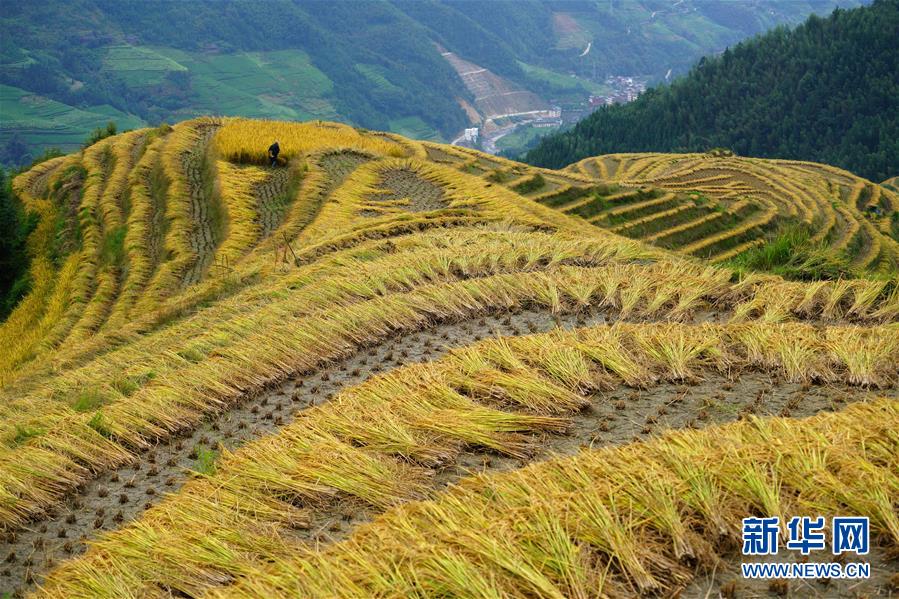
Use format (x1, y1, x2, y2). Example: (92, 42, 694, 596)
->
(0, 251, 897, 522)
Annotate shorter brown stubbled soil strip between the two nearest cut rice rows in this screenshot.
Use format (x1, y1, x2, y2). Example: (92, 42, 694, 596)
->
(285, 372, 899, 556)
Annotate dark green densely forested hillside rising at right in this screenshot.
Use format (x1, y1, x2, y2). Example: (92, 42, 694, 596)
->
(527, 0, 899, 181)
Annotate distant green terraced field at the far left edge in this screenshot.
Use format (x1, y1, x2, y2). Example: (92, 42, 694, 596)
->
(0, 84, 144, 161)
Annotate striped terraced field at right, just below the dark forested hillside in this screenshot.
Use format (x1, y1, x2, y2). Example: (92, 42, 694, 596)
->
(567, 154, 899, 273)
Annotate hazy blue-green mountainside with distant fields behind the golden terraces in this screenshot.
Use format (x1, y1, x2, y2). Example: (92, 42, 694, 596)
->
(0, 0, 860, 164)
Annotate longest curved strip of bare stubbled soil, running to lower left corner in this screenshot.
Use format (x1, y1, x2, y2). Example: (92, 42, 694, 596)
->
(0, 310, 601, 594)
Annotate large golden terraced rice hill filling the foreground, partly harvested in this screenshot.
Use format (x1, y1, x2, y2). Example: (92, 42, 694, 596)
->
(0, 119, 899, 597)
